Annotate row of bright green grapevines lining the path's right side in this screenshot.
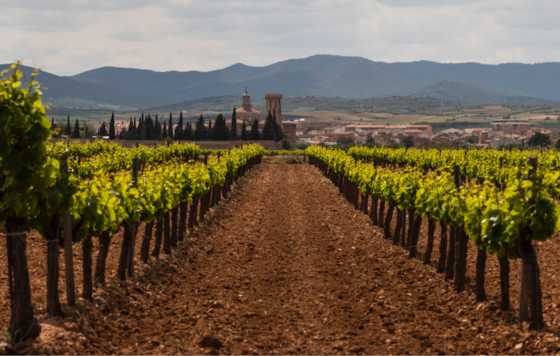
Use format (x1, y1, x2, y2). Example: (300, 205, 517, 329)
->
(306, 147, 557, 329)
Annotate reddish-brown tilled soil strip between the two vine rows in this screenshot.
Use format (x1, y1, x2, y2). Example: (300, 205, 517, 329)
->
(0, 163, 560, 354)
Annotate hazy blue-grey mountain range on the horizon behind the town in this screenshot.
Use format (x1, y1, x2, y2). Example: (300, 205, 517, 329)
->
(0, 55, 560, 110)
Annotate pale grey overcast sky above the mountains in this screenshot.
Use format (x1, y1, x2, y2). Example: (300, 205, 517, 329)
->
(0, 0, 560, 74)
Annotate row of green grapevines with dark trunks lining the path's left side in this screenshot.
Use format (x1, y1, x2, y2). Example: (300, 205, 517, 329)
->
(0, 140, 265, 343)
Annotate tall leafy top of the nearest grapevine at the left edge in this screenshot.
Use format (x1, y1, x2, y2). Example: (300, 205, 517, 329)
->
(0, 63, 59, 220)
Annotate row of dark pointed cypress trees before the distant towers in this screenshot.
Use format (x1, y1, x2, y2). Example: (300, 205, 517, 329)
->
(98, 108, 283, 141)
